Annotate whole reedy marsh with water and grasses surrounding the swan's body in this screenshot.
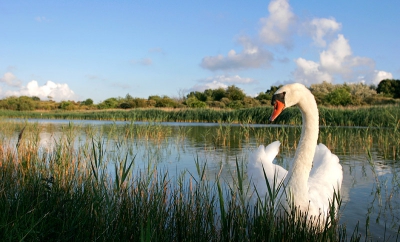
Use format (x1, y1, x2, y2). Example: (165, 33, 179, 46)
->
(0, 120, 400, 241)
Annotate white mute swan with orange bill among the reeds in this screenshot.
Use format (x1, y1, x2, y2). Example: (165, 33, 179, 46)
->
(247, 83, 343, 223)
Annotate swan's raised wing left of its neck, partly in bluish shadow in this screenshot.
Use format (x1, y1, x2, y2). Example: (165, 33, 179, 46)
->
(247, 141, 287, 199)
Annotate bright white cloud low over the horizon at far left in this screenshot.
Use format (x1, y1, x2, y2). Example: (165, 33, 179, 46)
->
(4, 80, 77, 101)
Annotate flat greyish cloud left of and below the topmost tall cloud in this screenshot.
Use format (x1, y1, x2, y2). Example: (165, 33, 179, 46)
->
(200, 36, 274, 71)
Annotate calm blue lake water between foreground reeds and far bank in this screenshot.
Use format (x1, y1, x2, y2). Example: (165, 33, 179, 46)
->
(7, 120, 400, 241)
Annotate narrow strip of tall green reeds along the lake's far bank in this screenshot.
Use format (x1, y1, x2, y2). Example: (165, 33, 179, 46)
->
(0, 105, 400, 127)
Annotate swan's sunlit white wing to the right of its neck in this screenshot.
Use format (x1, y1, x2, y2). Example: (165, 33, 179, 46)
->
(308, 144, 343, 212)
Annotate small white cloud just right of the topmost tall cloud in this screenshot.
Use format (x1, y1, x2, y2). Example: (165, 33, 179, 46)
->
(306, 18, 342, 47)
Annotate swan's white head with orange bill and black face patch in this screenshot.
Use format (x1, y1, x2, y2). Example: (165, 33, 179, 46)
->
(269, 83, 310, 122)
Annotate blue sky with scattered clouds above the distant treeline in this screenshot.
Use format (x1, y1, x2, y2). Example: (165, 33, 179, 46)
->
(0, 0, 400, 103)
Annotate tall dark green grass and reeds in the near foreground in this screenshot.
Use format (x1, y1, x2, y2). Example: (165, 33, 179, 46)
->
(0, 124, 360, 241)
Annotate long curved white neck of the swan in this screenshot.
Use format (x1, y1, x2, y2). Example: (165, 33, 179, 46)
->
(287, 93, 319, 208)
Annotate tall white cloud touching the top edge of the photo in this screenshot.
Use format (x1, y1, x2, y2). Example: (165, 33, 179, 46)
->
(259, 0, 295, 47)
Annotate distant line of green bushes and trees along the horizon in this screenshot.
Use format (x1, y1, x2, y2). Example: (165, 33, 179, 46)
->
(0, 79, 400, 111)
